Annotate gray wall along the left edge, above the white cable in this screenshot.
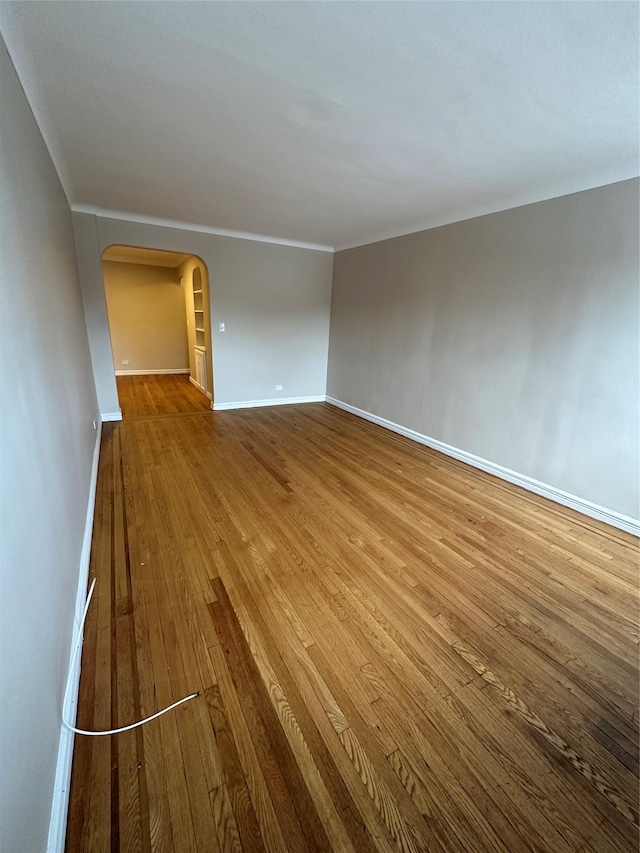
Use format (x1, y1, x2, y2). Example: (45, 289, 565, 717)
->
(0, 39, 98, 853)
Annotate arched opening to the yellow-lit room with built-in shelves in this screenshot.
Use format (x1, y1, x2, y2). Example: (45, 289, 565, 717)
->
(102, 245, 214, 419)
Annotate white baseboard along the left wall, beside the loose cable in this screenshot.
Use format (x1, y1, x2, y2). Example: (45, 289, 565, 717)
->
(47, 423, 102, 853)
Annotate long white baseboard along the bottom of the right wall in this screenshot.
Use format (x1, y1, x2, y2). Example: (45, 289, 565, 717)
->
(326, 397, 640, 536)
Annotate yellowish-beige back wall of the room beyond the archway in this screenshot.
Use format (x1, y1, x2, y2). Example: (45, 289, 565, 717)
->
(102, 261, 189, 372)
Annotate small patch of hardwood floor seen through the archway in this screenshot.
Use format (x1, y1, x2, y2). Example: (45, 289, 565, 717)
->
(116, 373, 211, 420)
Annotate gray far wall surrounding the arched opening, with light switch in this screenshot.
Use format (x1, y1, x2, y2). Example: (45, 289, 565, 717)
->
(73, 212, 333, 412)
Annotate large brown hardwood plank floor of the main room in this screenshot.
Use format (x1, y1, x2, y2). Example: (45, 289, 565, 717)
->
(67, 404, 639, 853)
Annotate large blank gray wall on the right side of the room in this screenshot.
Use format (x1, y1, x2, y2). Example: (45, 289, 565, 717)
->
(327, 180, 639, 518)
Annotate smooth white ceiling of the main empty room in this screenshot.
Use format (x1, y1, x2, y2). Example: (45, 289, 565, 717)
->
(0, 2, 639, 248)
